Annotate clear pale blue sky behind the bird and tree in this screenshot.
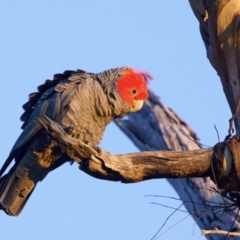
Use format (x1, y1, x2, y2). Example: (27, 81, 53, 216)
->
(0, 0, 230, 240)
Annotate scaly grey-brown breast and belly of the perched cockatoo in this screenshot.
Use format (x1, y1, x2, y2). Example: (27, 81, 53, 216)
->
(61, 80, 112, 147)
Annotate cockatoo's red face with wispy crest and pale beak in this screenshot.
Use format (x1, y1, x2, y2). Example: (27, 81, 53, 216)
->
(116, 68, 152, 112)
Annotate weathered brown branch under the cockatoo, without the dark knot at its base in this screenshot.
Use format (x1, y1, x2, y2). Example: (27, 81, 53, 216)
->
(39, 116, 214, 183)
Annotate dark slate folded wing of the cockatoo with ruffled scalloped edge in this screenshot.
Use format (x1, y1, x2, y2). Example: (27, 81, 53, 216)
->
(0, 70, 86, 176)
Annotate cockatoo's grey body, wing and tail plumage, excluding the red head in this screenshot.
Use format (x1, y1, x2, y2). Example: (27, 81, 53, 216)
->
(0, 68, 142, 216)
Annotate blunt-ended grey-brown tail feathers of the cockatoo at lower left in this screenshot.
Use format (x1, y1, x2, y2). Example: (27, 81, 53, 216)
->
(0, 167, 35, 216)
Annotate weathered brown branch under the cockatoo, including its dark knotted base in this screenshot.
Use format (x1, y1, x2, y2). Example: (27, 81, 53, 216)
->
(39, 116, 240, 191)
